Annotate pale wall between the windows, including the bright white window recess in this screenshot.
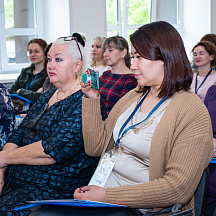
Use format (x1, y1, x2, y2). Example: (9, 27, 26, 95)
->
(43, 0, 107, 68)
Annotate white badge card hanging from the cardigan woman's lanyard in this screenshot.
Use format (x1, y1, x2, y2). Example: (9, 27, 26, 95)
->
(89, 150, 117, 187)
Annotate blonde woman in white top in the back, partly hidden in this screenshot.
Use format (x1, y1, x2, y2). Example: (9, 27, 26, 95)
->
(88, 36, 111, 77)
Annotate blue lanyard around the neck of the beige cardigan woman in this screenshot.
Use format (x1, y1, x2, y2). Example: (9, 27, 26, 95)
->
(115, 90, 168, 146)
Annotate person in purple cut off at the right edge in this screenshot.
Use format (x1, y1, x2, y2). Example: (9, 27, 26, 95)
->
(204, 85, 216, 216)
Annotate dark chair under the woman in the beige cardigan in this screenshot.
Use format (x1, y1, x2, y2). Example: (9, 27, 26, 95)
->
(145, 167, 209, 216)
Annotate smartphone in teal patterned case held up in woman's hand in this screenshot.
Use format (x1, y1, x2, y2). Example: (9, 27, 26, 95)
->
(82, 68, 99, 91)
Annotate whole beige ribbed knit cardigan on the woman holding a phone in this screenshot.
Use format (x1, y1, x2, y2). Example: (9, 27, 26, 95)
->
(83, 90, 213, 213)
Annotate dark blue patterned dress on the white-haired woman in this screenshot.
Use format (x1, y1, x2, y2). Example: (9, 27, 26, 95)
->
(0, 90, 106, 215)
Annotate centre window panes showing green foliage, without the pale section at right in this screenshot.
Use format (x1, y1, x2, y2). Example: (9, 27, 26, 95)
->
(106, 0, 151, 41)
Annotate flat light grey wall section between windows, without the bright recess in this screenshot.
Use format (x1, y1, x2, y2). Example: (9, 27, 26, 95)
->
(69, 0, 107, 68)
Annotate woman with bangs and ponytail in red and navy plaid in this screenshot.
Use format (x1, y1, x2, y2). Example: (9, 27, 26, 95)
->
(99, 36, 137, 113)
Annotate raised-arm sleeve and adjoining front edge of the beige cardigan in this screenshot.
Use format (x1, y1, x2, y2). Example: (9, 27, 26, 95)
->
(82, 90, 139, 156)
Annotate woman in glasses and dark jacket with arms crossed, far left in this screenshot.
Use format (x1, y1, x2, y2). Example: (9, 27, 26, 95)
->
(9, 38, 47, 102)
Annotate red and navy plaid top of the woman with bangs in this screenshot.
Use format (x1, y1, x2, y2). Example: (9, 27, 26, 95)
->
(99, 70, 137, 113)
